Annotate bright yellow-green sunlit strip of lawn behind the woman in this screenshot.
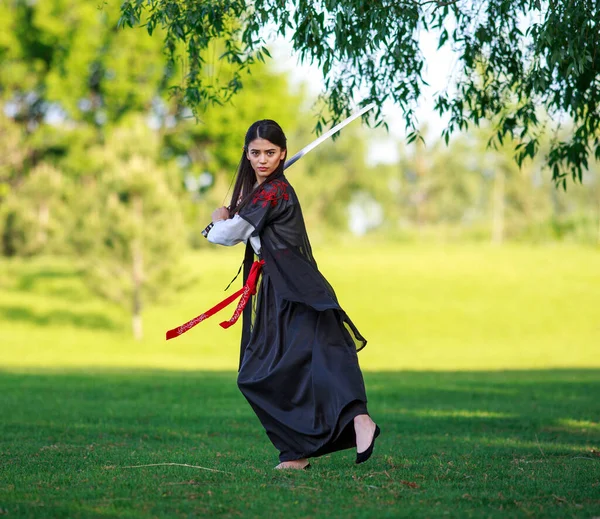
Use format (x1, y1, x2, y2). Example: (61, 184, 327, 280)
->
(0, 245, 600, 370)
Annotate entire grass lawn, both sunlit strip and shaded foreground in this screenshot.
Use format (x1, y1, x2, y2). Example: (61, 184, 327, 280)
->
(0, 245, 600, 519)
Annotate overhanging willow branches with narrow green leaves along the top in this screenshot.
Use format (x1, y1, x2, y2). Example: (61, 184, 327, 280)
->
(120, 0, 600, 187)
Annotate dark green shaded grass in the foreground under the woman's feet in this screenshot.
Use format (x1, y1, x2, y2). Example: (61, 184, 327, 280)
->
(0, 369, 600, 517)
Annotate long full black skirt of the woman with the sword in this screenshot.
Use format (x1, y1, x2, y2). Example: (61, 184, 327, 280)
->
(238, 271, 367, 461)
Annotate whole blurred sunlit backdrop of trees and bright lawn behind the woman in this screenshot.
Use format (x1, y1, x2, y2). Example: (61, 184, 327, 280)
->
(0, 0, 600, 370)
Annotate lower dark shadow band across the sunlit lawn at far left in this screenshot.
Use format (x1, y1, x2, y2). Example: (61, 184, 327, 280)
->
(0, 305, 121, 330)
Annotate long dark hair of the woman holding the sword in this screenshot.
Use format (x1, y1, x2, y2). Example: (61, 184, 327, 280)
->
(229, 119, 287, 216)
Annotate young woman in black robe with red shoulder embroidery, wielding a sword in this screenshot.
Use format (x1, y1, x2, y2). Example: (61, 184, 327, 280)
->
(207, 120, 380, 469)
